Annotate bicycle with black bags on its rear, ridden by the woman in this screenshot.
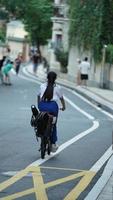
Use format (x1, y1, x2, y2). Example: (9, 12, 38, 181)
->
(31, 105, 56, 159)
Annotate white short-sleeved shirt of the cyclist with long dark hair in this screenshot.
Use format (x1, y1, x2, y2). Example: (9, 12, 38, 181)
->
(38, 83, 63, 101)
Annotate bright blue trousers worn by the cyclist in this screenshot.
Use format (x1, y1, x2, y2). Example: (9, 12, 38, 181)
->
(38, 101, 58, 144)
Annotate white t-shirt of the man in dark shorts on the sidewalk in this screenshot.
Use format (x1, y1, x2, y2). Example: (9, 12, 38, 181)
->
(79, 61, 90, 74)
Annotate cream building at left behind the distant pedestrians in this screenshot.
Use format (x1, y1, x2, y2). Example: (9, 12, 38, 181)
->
(6, 20, 29, 61)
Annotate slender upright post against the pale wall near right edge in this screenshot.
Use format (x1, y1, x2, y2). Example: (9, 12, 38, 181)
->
(100, 45, 107, 88)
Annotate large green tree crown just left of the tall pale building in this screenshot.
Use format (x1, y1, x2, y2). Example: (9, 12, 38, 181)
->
(23, 0, 53, 51)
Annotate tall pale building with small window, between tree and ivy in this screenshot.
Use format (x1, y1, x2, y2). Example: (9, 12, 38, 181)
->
(49, 0, 69, 71)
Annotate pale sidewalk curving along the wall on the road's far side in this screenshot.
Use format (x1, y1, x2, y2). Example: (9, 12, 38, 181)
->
(27, 64, 113, 114)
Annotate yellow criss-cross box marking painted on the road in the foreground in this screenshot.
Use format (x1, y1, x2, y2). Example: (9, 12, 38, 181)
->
(0, 166, 95, 200)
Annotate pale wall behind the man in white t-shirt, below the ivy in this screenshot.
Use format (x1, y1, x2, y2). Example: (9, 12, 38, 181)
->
(68, 47, 113, 89)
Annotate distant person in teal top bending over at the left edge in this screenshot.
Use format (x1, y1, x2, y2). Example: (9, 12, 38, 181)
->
(2, 60, 13, 85)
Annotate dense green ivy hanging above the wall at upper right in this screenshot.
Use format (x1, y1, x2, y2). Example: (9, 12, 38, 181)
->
(69, 0, 113, 62)
